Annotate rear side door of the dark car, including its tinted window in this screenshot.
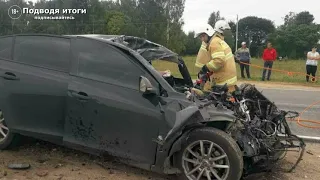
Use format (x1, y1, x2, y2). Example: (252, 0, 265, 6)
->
(0, 36, 71, 142)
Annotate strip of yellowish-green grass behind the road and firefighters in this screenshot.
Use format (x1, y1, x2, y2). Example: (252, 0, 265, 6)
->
(153, 56, 320, 85)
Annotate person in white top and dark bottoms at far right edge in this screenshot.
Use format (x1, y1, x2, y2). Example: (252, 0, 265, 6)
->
(306, 46, 320, 82)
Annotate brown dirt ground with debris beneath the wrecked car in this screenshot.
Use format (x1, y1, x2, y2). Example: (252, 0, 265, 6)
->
(0, 142, 320, 180)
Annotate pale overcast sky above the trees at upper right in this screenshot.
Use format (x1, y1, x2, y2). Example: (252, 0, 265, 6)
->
(183, 0, 320, 33)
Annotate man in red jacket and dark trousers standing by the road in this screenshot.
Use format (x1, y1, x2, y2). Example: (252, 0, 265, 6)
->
(262, 42, 277, 81)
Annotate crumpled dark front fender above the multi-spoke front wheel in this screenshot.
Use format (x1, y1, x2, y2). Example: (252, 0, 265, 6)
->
(152, 101, 235, 172)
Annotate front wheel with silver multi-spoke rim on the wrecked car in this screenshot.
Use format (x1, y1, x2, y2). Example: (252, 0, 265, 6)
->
(177, 127, 243, 180)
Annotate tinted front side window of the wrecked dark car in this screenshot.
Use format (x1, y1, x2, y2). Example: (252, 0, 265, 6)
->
(76, 38, 144, 90)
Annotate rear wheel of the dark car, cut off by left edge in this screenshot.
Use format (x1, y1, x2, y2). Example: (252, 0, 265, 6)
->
(0, 110, 19, 150)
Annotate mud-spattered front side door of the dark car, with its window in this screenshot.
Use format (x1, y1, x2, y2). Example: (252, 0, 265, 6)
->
(64, 38, 164, 165)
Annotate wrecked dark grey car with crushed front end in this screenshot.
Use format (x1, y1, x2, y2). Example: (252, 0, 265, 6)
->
(0, 34, 304, 180)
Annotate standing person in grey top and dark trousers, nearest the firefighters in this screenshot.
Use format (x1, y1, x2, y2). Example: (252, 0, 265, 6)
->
(236, 42, 251, 79)
